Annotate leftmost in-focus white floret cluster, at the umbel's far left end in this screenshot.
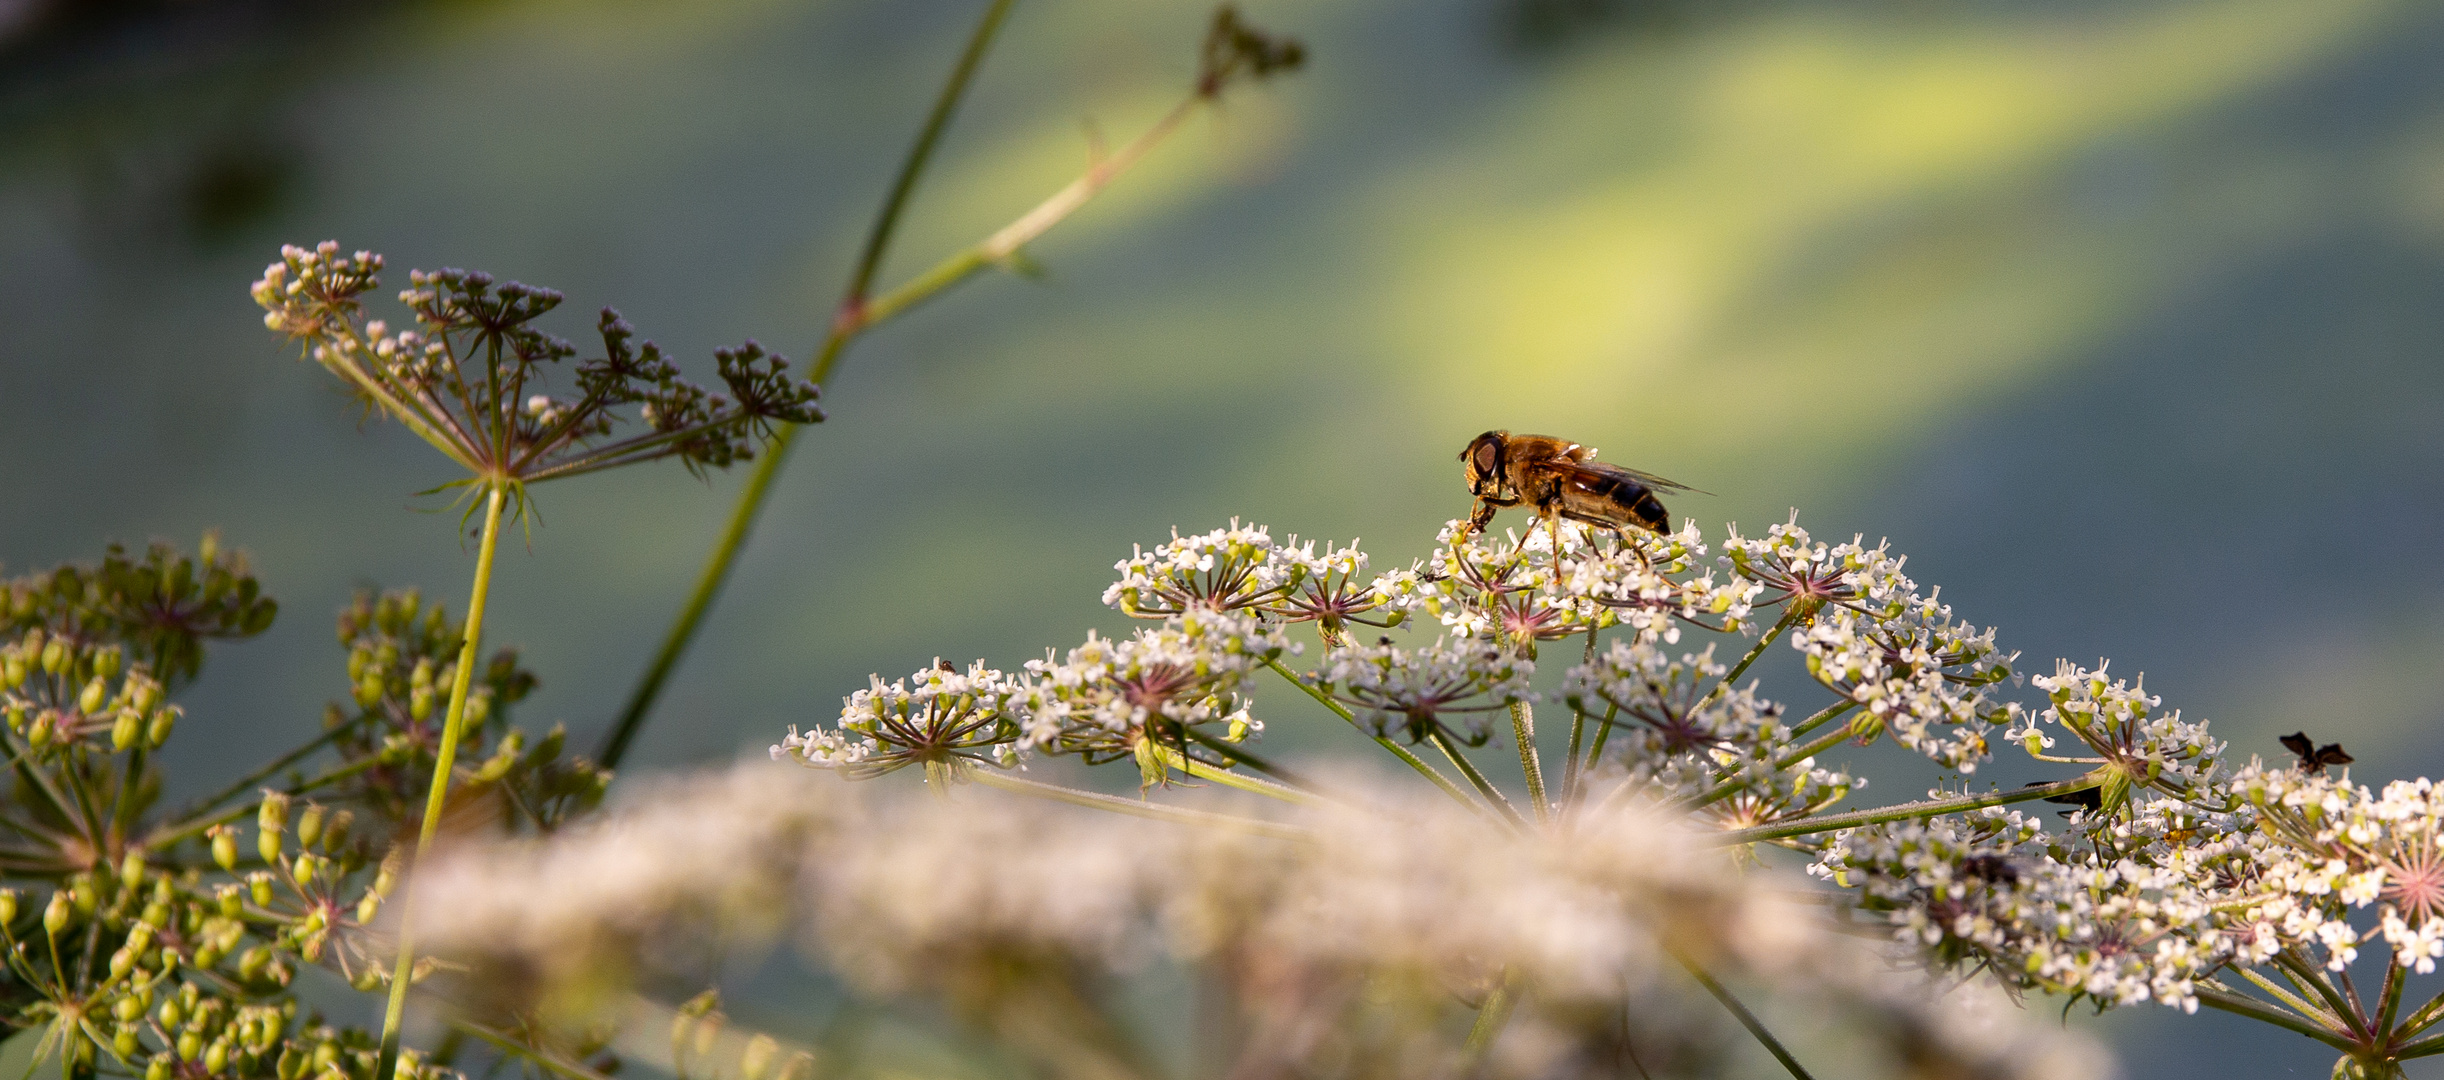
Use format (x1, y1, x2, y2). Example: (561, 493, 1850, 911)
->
(772, 660, 1036, 777)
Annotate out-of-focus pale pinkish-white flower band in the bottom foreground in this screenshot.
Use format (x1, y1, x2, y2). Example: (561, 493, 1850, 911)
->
(413, 765, 2109, 1080)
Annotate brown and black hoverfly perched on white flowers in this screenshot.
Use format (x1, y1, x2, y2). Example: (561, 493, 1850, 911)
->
(1459, 430, 1696, 542)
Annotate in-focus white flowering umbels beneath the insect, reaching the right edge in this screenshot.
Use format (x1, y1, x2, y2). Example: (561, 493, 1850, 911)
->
(775, 503, 2444, 1078)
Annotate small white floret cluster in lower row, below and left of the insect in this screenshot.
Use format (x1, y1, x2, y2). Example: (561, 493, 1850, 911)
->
(1312, 638, 1535, 745)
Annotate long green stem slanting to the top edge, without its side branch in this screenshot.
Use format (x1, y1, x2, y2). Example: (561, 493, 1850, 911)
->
(596, 0, 1014, 770)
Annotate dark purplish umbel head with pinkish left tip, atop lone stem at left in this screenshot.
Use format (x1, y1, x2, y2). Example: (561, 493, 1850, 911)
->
(254, 242, 824, 500)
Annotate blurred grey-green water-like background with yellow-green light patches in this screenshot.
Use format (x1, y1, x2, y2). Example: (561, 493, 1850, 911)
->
(0, 0, 2444, 1078)
